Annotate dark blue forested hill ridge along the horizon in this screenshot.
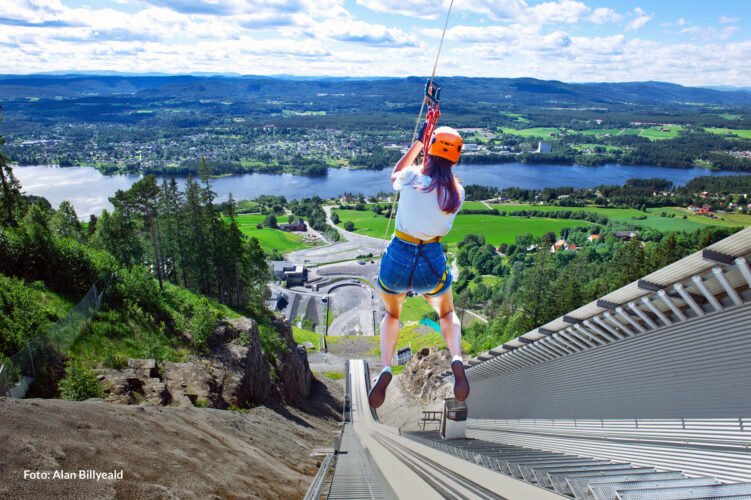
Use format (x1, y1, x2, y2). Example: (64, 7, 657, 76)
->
(0, 75, 751, 106)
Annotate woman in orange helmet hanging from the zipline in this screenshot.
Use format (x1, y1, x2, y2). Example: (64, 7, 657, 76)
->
(368, 121, 469, 408)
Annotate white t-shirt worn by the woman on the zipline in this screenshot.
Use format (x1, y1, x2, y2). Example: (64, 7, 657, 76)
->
(394, 165, 464, 240)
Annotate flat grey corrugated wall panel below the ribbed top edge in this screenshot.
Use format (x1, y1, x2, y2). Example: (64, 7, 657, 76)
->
(467, 306, 751, 419)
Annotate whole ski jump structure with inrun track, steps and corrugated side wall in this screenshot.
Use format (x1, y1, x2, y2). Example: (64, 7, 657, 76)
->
(309, 228, 751, 500)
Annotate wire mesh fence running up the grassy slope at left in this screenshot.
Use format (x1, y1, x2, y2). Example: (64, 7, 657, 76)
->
(0, 284, 104, 398)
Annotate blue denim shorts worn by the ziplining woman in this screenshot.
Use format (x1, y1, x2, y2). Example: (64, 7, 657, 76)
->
(378, 236, 453, 297)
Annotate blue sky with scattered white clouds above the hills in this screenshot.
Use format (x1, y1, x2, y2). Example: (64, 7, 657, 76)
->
(0, 0, 751, 87)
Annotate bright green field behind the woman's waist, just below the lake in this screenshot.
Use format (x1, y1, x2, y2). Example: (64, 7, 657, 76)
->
(336, 204, 591, 248)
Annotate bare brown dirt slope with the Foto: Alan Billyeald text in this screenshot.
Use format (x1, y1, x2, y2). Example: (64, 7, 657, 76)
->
(0, 377, 343, 499)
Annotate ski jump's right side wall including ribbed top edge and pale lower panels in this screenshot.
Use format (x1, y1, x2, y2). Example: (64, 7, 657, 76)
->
(452, 228, 751, 484)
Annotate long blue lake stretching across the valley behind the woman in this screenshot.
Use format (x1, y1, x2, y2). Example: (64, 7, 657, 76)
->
(13, 163, 751, 218)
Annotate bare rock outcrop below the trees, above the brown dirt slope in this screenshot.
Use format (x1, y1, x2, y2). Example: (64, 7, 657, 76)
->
(99, 318, 313, 409)
